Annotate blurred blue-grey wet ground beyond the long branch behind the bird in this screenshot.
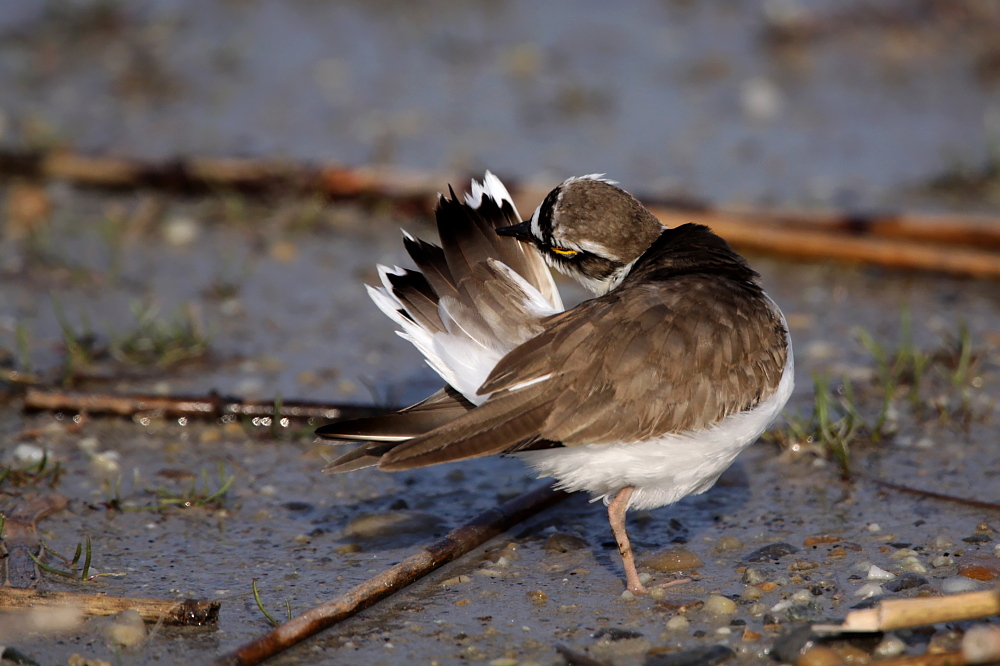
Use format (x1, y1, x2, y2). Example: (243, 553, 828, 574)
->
(0, 0, 1000, 207)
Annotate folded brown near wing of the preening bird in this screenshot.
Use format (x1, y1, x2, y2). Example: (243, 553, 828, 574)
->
(372, 275, 787, 470)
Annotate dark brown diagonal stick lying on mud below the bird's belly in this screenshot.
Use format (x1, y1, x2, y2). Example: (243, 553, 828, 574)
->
(212, 486, 567, 666)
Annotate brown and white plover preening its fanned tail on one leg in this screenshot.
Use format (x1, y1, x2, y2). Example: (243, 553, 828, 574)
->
(316, 171, 794, 595)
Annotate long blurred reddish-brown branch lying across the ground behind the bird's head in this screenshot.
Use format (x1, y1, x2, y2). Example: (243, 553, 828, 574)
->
(0, 150, 1000, 279)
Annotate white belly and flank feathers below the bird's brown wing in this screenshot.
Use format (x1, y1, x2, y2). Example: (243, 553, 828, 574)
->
(515, 329, 795, 509)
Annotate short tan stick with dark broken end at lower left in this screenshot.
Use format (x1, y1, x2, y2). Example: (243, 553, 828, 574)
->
(0, 587, 220, 626)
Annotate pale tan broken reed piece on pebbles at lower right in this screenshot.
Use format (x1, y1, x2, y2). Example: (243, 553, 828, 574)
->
(813, 589, 1000, 633)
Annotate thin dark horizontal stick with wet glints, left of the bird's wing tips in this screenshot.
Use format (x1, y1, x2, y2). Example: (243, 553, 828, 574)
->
(23, 388, 395, 421)
